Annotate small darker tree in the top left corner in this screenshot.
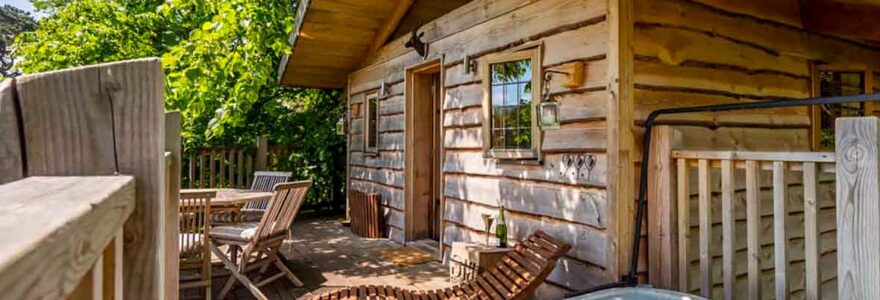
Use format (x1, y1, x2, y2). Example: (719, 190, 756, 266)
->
(0, 5, 37, 79)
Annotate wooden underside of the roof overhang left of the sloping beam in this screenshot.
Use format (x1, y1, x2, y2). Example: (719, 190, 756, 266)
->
(278, 0, 471, 89)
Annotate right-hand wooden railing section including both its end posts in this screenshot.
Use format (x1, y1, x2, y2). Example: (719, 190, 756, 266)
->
(648, 117, 880, 299)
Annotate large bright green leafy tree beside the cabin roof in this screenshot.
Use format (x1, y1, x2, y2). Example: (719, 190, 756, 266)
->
(15, 0, 344, 211)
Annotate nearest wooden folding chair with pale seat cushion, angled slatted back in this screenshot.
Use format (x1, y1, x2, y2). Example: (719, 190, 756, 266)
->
(209, 181, 312, 300)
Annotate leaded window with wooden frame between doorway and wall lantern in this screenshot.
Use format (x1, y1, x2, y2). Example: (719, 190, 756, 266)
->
(481, 47, 541, 159)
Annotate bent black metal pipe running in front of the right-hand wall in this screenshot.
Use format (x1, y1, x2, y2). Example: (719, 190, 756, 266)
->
(572, 94, 880, 296)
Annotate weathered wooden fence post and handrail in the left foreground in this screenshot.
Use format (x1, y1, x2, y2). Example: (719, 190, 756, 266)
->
(0, 58, 168, 299)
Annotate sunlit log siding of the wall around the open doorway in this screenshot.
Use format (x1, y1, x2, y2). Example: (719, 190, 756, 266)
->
(349, 0, 615, 292)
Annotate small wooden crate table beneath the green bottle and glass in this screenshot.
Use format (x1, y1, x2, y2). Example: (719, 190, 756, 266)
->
(449, 242, 513, 283)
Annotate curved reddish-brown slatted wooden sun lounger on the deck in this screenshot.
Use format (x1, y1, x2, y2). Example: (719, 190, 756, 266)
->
(313, 231, 571, 300)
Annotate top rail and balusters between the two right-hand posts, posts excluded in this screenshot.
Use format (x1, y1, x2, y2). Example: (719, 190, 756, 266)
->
(672, 151, 834, 299)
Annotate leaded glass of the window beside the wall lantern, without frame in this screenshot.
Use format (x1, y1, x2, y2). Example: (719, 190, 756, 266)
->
(490, 59, 532, 150)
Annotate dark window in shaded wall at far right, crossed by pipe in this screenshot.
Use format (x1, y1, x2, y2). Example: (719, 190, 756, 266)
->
(814, 71, 865, 150)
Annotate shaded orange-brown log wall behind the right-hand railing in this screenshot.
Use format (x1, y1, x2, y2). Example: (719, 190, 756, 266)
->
(633, 0, 880, 297)
